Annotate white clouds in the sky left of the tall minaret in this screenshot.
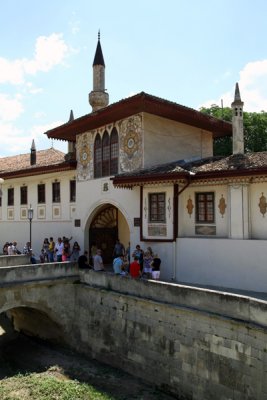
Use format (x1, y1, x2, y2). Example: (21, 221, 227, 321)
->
(0, 33, 71, 156)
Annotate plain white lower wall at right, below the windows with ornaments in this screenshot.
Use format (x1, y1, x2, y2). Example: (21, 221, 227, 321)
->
(176, 238, 267, 292)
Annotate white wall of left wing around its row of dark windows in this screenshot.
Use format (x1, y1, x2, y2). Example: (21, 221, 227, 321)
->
(0, 171, 76, 256)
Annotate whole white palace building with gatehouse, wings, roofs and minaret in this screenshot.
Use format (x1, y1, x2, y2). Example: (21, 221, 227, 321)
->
(0, 33, 267, 291)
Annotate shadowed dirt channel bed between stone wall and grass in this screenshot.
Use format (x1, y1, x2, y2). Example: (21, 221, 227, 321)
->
(0, 334, 178, 400)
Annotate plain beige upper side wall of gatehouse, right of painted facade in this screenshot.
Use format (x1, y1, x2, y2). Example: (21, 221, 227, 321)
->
(143, 113, 213, 167)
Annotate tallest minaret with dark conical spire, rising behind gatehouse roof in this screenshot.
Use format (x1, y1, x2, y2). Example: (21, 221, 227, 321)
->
(89, 32, 109, 112)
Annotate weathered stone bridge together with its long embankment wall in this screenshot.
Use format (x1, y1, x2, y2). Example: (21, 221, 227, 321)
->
(0, 263, 267, 400)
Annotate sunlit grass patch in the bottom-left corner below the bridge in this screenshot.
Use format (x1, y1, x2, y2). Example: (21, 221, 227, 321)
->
(0, 371, 114, 400)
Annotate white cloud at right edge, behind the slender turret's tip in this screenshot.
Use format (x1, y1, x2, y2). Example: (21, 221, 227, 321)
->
(198, 60, 267, 112)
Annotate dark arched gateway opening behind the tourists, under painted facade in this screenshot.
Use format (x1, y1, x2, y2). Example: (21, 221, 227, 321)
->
(89, 204, 130, 264)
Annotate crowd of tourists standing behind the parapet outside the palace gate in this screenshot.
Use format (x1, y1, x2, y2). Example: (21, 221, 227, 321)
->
(3, 236, 161, 280)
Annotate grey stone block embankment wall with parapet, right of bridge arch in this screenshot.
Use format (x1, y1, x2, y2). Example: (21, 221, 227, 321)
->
(72, 271, 267, 400)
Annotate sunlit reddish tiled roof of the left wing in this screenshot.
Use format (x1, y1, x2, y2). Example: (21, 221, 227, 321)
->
(0, 148, 70, 174)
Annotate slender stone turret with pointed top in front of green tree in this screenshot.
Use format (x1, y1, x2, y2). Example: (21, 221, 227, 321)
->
(231, 83, 244, 154)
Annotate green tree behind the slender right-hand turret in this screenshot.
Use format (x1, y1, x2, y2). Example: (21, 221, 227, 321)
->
(200, 104, 267, 156)
